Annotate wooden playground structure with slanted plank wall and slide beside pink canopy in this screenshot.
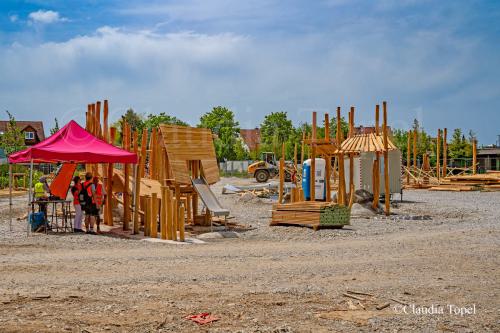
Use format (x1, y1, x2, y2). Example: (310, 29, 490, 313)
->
(86, 100, 229, 241)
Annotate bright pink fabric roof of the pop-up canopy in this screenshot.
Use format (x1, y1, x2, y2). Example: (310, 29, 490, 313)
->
(9, 120, 137, 164)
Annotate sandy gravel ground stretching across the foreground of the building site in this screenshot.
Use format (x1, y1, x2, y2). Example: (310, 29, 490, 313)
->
(0, 178, 500, 332)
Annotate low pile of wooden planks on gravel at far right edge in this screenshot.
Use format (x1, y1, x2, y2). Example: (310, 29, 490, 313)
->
(430, 173, 500, 192)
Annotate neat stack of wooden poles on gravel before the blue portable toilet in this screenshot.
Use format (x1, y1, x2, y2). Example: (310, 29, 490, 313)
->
(270, 201, 351, 230)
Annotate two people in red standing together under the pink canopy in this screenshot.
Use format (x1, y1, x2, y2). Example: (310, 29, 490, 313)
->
(71, 172, 106, 234)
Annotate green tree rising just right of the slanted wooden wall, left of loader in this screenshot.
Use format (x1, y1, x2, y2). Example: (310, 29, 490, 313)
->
(198, 106, 240, 160)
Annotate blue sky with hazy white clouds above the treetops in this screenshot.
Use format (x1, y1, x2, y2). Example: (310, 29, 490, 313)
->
(0, 0, 500, 145)
